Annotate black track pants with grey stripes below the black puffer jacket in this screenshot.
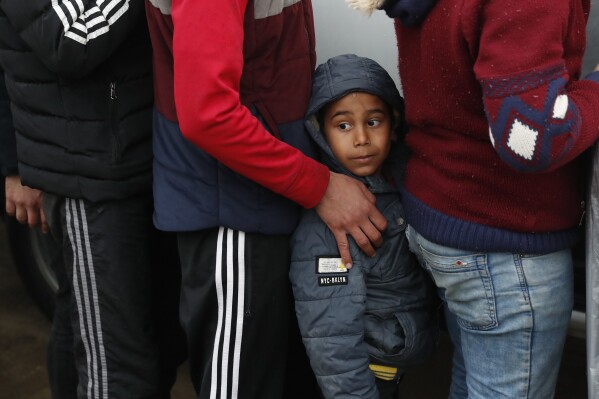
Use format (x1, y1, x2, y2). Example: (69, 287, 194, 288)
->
(44, 194, 185, 399)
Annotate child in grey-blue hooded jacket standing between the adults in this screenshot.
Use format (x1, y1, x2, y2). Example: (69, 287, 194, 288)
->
(290, 54, 437, 399)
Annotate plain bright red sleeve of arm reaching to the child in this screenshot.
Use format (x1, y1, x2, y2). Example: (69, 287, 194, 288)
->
(172, 0, 329, 208)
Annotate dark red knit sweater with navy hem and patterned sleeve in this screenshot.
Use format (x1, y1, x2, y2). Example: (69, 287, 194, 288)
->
(396, 0, 599, 253)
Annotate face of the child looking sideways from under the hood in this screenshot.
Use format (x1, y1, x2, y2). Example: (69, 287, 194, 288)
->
(324, 92, 392, 176)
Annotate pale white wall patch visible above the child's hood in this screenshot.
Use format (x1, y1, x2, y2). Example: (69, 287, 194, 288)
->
(312, 0, 401, 89)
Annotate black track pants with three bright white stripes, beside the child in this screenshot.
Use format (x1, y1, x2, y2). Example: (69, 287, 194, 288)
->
(178, 227, 319, 399)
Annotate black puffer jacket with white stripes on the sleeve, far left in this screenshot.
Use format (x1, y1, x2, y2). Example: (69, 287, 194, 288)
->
(0, 0, 153, 201)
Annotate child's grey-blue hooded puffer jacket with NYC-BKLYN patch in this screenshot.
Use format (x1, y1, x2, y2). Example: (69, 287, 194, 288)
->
(290, 55, 437, 399)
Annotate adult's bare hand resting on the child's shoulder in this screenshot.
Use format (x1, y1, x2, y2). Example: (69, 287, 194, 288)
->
(316, 172, 387, 268)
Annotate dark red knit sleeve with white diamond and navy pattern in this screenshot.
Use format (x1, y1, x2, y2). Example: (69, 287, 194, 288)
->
(474, 0, 599, 172)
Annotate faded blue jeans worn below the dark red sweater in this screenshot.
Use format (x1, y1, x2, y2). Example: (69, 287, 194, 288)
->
(407, 227, 574, 399)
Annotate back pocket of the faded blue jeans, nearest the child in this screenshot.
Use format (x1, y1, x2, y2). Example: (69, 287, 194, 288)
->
(419, 246, 498, 330)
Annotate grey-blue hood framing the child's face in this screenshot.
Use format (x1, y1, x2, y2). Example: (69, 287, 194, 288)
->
(305, 54, 406, 192)
